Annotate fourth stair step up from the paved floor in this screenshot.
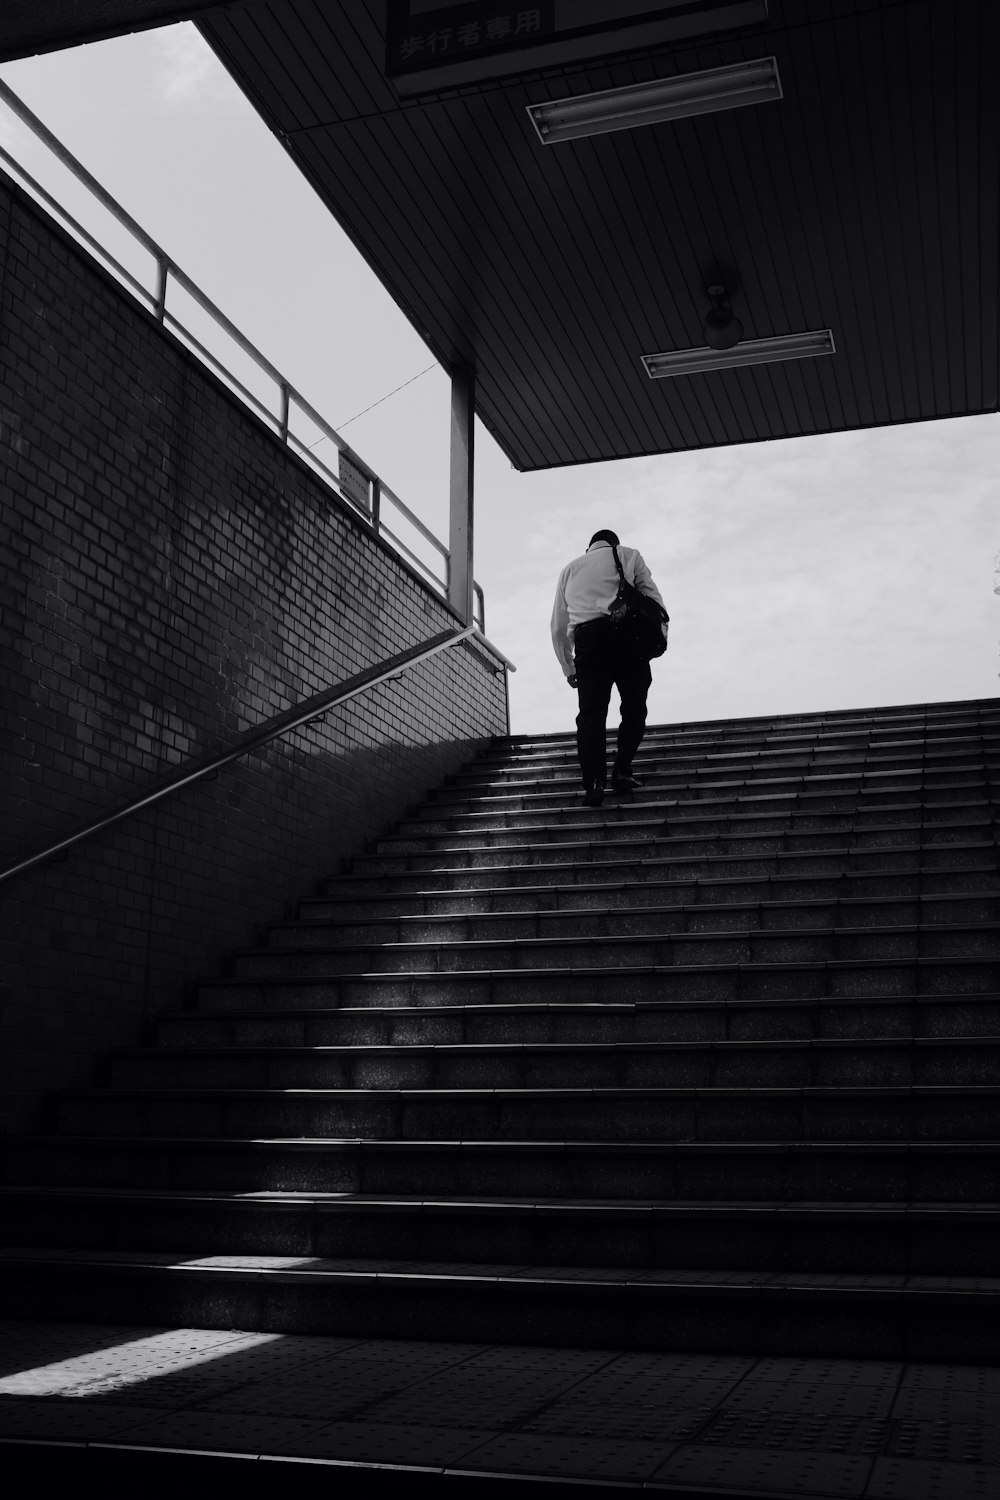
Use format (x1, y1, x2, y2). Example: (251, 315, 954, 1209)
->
(55, 1085, 1000, 1142)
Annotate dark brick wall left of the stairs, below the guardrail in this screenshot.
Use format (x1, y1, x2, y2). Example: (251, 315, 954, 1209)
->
(0, 176, 507, 1128)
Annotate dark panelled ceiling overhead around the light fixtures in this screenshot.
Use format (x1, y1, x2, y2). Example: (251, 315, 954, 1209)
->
(0, 0, 1000, 470)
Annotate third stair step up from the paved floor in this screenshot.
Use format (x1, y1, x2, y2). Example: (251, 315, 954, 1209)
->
(1, 1133, 1000, 1194)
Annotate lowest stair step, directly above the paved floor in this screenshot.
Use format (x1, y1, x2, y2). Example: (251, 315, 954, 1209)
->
(0, 1250, 1000, 1364)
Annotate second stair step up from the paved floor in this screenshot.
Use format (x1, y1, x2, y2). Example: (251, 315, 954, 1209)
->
(0, 1188, 1000, 1277)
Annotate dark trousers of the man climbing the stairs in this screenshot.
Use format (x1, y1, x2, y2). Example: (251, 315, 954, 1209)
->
(573, 620, 652, 788)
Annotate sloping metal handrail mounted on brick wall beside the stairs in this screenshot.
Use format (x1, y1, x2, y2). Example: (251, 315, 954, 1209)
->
(0, 626, 479, 884)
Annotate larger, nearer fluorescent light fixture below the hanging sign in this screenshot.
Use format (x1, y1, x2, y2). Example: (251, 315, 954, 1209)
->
(528, 57, 781, 146)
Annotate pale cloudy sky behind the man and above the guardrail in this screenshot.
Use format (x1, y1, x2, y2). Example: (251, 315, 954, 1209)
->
(0, 26, 1000, 734)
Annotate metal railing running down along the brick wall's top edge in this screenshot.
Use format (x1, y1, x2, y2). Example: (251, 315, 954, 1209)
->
(0, 80, 486, 630)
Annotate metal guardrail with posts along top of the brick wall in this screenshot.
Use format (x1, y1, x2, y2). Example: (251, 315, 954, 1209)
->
(0, 80, 486, 630)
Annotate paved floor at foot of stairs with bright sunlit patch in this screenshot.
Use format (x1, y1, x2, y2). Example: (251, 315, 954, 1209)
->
(0, 1322, 1000, 1500)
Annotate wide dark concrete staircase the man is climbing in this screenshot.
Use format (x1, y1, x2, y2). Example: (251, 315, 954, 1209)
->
(0, 699, 1000, 1364)
